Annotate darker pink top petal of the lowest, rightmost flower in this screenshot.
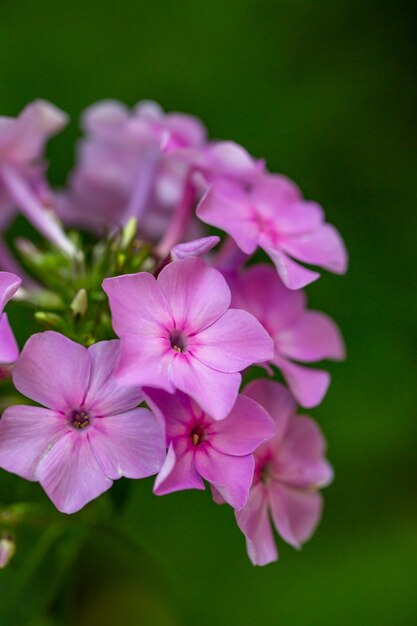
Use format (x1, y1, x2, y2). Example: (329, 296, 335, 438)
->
(243, 378, 297, 442)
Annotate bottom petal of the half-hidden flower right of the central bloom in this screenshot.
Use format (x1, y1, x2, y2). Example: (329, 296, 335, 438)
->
(273, 355, 330, 408)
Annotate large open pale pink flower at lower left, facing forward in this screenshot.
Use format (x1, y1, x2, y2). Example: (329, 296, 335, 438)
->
(0, 332, 165, 513)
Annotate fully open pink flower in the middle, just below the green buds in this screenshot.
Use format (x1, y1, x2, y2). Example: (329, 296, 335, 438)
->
(103, 257, 273, 419)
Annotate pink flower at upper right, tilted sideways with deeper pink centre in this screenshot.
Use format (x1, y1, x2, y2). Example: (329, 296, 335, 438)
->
(197, 174, 347, 289)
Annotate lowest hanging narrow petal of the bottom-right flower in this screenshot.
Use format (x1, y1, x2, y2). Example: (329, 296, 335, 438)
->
(236, 484, 278, 565)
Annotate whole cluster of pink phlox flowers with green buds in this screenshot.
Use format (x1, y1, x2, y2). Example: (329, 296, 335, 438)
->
(0, 101, 347, 565)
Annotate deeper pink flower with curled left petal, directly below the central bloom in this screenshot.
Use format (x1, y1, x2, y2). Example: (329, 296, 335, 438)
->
(144, 388, 275, 510)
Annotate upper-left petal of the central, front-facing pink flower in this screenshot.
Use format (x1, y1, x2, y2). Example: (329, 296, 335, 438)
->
(103, 272, 172, 336)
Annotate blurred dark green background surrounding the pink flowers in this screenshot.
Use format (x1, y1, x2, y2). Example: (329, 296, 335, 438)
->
(0, 0, 417, 626)
